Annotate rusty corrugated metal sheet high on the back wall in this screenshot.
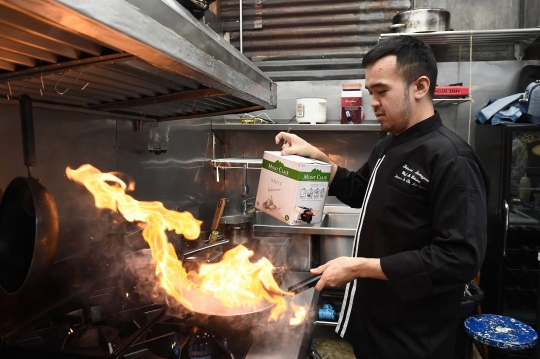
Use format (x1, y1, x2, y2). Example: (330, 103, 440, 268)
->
(222, 0, 410, 61)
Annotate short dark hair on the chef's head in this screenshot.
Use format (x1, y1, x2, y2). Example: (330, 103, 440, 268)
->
(362, 35, 438, 98)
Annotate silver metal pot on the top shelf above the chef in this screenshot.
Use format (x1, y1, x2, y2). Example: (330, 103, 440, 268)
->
(389, 9, 450, 33)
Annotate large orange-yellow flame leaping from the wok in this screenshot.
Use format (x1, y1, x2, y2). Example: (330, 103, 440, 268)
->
(66, 164, 306, 325)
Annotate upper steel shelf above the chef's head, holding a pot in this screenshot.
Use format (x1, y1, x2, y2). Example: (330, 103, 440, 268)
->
(379, 28, 540, 60)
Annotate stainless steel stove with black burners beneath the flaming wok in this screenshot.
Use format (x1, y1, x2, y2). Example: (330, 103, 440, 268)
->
(0, 273, 317, 359)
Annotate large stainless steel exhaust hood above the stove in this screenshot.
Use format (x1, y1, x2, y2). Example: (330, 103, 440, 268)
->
(0, 0, 277, 121)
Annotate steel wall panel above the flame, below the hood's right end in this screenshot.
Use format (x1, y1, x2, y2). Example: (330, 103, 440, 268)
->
(118, 119, 223, 230)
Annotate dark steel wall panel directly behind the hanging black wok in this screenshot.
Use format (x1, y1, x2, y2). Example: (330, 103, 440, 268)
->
(0, 100, 118, 262)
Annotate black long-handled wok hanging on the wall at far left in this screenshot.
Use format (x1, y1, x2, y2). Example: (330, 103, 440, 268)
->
(0, 95, 58, 294)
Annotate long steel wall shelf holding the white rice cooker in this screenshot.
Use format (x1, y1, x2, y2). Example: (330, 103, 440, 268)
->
(212, 122, 381, 132)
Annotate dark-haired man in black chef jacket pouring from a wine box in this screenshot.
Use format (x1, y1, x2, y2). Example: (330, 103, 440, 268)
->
(276, 36, 489, 359)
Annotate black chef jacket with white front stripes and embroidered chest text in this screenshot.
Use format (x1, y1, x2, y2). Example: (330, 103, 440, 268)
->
(329, 113, 489, 359)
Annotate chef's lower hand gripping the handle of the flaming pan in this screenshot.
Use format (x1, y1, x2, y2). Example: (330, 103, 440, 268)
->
(311, 257, 387, 291)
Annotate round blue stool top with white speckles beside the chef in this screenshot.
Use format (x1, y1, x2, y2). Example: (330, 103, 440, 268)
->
(465, 314, 538, 350)
